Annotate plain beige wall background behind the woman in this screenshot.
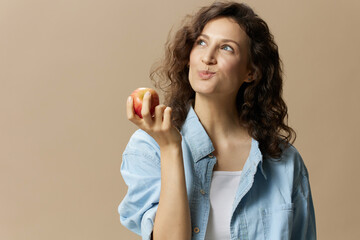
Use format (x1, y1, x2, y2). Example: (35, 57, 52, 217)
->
(0, 0, 360, 240)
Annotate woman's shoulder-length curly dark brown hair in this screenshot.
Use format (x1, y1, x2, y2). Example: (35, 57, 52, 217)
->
(150, 2, 296, 158)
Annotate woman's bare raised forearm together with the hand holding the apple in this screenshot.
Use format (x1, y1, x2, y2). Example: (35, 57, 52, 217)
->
(126, 92, 191, 239)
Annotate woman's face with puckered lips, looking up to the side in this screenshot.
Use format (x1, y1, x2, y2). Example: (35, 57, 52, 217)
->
(189, 17, 251, 96)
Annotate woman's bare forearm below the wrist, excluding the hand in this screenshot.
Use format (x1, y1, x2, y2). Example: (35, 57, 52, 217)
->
(153, 146, 191, 240)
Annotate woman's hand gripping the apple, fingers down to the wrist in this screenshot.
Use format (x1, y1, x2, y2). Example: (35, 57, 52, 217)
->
(126, 92, 181, 148)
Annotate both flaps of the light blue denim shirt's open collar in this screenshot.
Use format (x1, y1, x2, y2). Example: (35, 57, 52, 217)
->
(180, 105, 266, 178)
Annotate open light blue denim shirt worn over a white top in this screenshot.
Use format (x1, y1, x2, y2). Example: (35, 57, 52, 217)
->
(118, 107, 316, 240)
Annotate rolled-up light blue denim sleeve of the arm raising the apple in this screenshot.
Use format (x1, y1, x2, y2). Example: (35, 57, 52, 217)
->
(118, 132, 161, 240)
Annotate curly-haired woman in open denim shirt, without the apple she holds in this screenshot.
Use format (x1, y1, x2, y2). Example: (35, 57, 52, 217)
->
(119, 2, 316, 240)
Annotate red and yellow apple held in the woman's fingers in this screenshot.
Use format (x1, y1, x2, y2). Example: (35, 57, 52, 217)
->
(131, 88, 159, 118)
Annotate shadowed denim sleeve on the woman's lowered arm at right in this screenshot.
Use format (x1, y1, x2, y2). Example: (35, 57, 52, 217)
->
(291, 161, 316, 240)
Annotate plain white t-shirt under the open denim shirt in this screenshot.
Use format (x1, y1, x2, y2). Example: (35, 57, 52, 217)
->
(205, 171, 241, 240)
